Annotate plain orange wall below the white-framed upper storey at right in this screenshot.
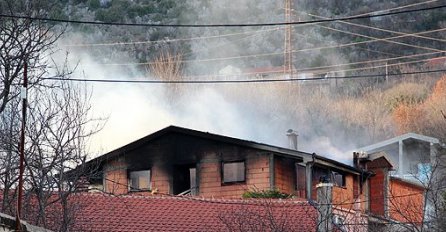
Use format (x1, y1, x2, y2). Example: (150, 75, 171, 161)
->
(388, 178, 424, 224)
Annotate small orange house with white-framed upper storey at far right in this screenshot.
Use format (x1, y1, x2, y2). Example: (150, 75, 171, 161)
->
(354, 133, 441, 230)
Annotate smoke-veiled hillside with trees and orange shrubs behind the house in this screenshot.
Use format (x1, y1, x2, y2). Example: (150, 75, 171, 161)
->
(2, 0, 446, 156)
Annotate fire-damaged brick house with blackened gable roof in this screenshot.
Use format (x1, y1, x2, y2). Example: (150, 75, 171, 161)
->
(79, 126, 361, 201)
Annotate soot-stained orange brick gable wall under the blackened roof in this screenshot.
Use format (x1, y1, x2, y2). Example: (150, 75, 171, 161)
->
(104, 142, 274, 198)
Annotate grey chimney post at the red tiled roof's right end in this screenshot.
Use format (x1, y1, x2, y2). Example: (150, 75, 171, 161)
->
(316, 178, 333, 232)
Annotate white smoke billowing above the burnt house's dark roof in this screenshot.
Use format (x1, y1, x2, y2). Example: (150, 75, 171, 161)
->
(52, 1, 354, 161)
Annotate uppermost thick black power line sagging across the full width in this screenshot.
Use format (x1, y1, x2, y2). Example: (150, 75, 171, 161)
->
(0, 5, 446, 28)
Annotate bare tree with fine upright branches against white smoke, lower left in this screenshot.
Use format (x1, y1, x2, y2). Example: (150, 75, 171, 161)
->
(0, 73, 100, 231)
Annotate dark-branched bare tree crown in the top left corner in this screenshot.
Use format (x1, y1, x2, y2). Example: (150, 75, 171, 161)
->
(0, 0, 64, 113)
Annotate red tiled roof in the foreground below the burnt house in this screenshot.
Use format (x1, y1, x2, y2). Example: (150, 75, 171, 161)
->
(68, 193, 317, 232)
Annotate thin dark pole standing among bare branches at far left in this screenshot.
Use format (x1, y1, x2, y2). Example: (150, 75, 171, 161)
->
(16, 59, 28, 231)
